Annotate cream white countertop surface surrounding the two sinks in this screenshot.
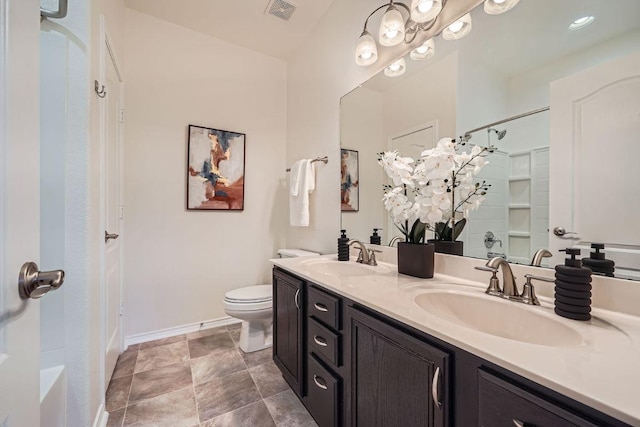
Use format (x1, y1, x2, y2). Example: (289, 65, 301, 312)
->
(271, 255, 640, 426)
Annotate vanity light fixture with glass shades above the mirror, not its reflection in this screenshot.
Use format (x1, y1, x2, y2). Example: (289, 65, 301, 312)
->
(355, 0, 447, 66)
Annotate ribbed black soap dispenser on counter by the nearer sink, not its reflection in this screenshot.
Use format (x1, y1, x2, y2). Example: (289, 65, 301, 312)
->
(554, 248, 591, 320)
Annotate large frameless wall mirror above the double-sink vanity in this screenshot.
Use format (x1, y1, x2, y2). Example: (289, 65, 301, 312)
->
(340, 0, 640, 278)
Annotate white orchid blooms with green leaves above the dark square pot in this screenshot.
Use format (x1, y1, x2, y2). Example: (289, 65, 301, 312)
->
(378, 138, 493, 243)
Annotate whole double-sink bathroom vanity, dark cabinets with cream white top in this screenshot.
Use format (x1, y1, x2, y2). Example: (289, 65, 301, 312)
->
(273, 256, 640, 427)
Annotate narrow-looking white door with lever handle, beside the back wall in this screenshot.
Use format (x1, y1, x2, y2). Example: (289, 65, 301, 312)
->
(101, 26, 122, 391)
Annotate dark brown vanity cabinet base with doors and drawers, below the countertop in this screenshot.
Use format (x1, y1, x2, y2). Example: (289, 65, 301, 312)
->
(273, 268, 628, 427)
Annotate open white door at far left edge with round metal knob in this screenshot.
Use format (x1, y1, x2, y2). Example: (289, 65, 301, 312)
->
(0, 0, 46, 427)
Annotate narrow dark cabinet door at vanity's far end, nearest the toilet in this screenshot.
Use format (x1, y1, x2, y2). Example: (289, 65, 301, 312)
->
(273, 271, 304, 396)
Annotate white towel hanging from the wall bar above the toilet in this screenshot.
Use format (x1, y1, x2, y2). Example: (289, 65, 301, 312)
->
(289, 159, 316, 227)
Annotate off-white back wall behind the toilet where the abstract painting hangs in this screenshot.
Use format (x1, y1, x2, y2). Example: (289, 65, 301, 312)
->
(124, 9, 288, 336)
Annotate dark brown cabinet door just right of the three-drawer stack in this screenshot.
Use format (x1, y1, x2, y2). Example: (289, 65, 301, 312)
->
(347, 307, 449, 427)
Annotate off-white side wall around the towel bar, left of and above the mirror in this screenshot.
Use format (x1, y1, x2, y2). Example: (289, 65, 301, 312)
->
(287, 0, 480, 253)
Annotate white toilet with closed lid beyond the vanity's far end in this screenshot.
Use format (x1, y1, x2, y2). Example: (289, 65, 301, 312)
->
(224, 249, 320, 353)
